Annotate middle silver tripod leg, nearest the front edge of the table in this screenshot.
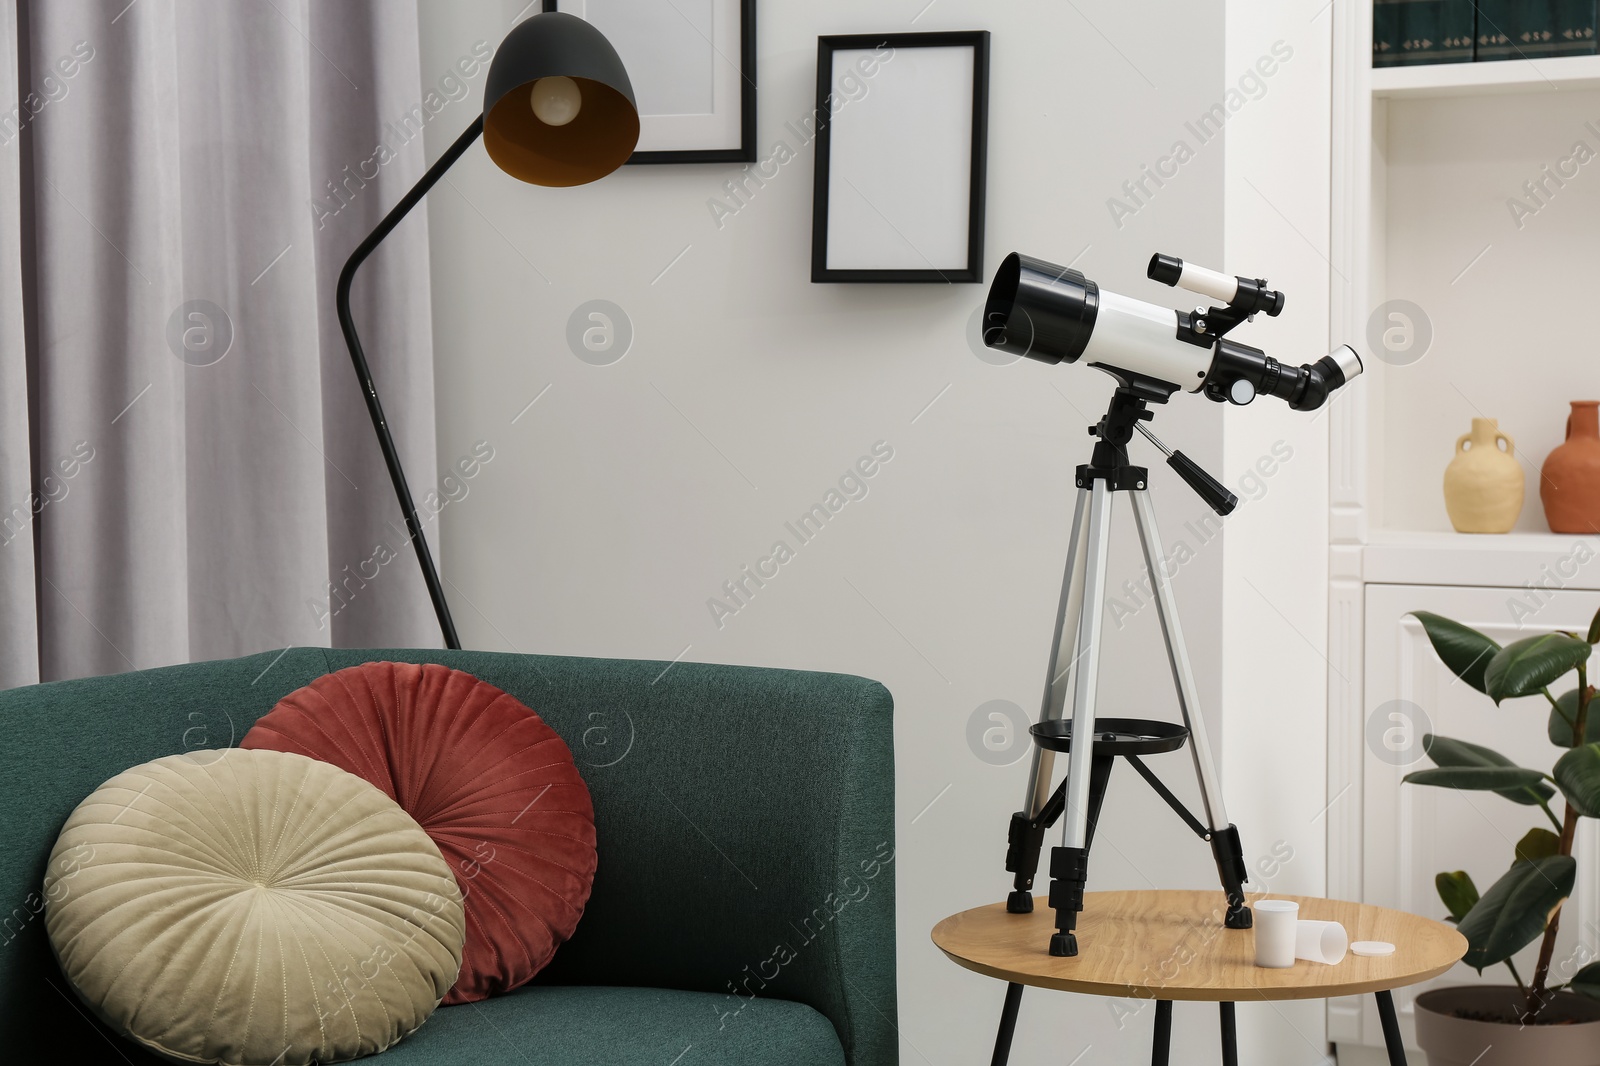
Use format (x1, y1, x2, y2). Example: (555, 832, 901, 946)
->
(1050, 480, 1112, 957)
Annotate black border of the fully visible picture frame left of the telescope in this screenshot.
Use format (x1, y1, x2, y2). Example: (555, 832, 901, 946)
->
(811, 30, 989, 283)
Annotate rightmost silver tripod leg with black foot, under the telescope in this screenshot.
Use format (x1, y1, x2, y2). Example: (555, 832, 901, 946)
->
(1133, 490, 1251, 928)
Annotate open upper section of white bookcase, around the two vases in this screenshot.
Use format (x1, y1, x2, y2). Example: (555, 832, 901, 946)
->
(1330, 14, 1600, 557)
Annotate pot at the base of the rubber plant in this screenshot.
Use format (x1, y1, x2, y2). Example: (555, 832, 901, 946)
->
(1416, 984, 1600, 1066)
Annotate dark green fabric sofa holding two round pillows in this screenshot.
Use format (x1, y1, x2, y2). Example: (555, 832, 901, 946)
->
(0, 648, 898, 1066)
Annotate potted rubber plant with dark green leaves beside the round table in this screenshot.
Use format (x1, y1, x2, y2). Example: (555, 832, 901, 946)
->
(1405, 611, 1600, 1066)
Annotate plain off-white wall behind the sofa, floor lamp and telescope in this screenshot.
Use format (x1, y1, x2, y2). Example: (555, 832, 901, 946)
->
(419, 0, 1325, 1064)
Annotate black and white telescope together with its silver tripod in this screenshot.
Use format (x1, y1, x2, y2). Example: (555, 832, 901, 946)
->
(982, 253, 1362, 1066)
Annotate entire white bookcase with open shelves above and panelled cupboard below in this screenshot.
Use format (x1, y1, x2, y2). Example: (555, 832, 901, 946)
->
(1328, 3, 1600, 1061)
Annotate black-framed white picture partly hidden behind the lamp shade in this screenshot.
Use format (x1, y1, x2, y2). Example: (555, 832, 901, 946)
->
(546, 0, 755, 163)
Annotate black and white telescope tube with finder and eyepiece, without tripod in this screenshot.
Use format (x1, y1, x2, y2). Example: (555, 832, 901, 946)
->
(982, 251, 1362, 411)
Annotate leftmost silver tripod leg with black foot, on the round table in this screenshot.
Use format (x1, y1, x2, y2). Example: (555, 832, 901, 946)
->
(1005, 488, 1090, 914)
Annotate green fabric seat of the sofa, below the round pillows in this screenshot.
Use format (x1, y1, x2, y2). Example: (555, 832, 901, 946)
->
(382, 985, 845, 1066)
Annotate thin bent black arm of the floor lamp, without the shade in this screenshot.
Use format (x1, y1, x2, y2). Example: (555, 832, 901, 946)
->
(334, 115, 483, 648)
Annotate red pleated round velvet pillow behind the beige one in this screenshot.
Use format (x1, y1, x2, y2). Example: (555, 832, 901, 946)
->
(240, 663, 595, 1004)
